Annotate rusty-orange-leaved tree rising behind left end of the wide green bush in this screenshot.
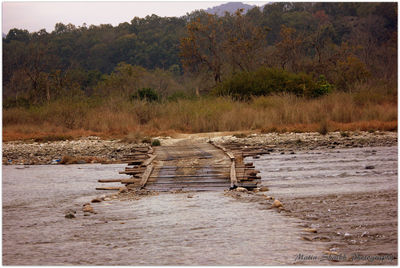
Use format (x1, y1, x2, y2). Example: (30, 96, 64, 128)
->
(180, 10, 267, 87)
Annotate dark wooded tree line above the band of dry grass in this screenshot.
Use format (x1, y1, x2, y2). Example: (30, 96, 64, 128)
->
(3, 2, 397, 106)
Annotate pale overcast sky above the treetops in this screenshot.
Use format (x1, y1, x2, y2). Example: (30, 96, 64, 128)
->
(2, 1, 267, 34)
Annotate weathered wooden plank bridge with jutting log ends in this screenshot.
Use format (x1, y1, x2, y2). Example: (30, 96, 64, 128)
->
(96, 140, 267, 192)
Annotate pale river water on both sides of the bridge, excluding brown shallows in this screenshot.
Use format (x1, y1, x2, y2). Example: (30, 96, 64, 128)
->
(2, 147, 397, 265)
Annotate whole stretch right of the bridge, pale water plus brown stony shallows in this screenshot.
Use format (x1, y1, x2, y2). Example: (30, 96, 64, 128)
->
(250, 147, 398, 265)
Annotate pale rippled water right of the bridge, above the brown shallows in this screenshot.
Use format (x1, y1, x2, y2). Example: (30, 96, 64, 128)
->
(253, 146, 397, 197)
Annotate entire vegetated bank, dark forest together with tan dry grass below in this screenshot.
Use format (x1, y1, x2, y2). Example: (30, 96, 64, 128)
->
(3, 2, 398, 140)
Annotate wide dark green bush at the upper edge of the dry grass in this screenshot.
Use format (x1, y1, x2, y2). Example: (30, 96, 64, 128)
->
(214, 67, 332, 100)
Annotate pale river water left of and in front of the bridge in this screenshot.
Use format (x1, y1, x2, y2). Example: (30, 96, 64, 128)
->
(3, 164, 323, 265)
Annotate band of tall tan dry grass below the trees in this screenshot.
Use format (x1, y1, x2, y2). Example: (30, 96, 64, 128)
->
(3, 90, 397, 141)
